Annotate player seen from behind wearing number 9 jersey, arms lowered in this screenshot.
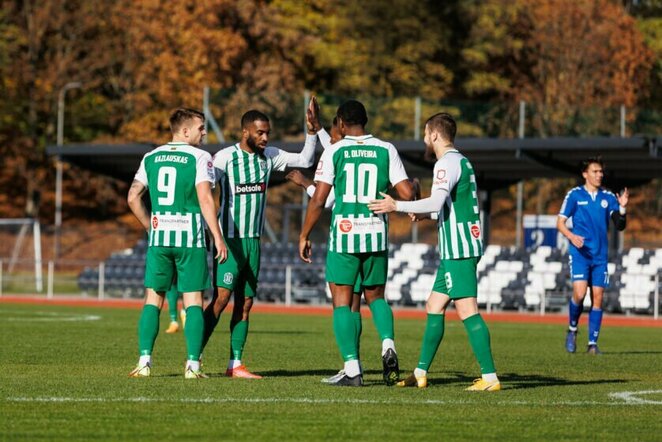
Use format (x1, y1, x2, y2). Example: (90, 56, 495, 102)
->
(127, 109, 227, 379)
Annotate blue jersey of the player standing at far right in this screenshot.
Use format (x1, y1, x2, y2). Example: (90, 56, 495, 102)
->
(559, 186, 619, 264)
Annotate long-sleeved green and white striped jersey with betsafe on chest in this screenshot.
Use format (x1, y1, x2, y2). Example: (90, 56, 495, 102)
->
(213, 135, 317, 238)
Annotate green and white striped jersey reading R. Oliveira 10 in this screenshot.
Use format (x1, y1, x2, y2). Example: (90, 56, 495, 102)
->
(315, 135, 407, 253)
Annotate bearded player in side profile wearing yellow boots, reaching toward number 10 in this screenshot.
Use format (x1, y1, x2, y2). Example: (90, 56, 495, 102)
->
(368, 113, 501, 391)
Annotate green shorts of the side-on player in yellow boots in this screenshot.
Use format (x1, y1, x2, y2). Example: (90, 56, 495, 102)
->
(432, 258, 480, 299)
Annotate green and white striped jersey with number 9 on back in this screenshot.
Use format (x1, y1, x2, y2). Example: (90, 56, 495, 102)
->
(134, 143, 215, 248)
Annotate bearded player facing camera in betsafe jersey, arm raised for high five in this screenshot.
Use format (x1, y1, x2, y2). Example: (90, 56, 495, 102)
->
(203, 100, 324, 379)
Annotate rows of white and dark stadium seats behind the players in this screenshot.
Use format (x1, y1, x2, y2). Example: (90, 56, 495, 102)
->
(78, 241, 662, 313)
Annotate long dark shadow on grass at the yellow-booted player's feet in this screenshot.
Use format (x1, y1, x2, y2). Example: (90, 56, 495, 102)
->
(428, 372, 628, 390)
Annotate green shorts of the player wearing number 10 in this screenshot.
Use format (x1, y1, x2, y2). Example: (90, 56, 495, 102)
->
(326, 250, 388, 293)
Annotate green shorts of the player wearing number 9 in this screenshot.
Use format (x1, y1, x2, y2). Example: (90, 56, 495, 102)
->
(145, 246, 211, 293)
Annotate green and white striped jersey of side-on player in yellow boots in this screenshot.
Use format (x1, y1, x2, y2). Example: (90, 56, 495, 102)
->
(432, 149, 483, 259)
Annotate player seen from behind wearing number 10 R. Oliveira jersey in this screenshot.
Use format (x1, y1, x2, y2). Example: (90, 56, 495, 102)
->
(299, 100, 414, 387)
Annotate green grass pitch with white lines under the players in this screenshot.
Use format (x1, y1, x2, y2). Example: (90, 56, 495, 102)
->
(0, 304, 662, 441)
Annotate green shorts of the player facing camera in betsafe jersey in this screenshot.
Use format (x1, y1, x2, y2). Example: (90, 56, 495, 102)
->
(216, 238, 260, 298)
